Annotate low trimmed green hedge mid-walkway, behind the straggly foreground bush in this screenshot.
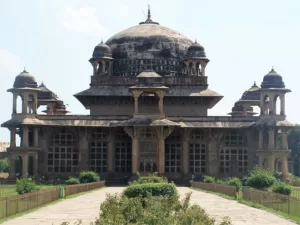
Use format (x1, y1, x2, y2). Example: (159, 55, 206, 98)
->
(124, 183, 178, 198)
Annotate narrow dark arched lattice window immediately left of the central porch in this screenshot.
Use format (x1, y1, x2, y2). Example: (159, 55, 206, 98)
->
(115, 130, 132, 173)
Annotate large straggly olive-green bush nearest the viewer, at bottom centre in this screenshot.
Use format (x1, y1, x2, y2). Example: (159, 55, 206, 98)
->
(95, 193, 231, 225)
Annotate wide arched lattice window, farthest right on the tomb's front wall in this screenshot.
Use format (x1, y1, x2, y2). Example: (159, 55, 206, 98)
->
(220, 131, 248, 176)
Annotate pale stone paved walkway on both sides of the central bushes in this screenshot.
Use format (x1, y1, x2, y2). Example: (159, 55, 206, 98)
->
(3, 187, 296, 225)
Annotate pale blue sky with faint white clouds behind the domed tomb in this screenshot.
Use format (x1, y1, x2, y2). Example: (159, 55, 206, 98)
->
(0, 0, 300, 141)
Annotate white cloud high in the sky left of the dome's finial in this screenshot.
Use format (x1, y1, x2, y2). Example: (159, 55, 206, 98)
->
(63, 7, 107, 34)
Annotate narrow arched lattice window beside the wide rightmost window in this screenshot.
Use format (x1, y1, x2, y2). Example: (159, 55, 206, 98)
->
(189, 130, 207, 174)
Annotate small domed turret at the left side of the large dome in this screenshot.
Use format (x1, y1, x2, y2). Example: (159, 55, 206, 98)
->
(90, 40, 113, 75)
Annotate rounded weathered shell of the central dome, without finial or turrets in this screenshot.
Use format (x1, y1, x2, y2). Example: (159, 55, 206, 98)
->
(106, 23, 192, 59)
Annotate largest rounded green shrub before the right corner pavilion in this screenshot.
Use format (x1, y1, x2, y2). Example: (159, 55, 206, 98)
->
(246, 167, 276, 189)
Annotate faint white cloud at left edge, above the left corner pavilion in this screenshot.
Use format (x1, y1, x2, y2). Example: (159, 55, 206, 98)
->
(0, 49, 24, 77)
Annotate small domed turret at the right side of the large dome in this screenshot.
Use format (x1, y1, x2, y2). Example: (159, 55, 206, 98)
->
(184, 41, 209, 76)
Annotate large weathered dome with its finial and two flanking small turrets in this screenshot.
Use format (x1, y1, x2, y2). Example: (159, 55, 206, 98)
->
(90, 9, 209, 76)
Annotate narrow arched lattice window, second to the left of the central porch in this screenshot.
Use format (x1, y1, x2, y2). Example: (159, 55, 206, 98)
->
(90, 128, 107, 173)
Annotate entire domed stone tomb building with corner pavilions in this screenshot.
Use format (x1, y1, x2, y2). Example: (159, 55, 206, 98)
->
(2, 10, 292, 184)
